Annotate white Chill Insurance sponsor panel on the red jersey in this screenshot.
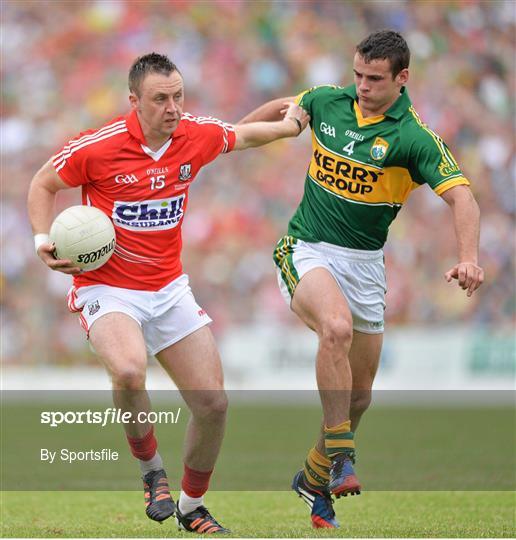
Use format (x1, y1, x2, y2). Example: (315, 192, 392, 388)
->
(111, 194, 185, 231)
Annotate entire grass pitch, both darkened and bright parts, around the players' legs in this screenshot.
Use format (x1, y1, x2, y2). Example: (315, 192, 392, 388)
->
(0, 395, 516, 538)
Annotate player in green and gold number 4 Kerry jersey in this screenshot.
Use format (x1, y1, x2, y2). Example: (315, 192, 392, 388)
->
(241, 30, 484, 528)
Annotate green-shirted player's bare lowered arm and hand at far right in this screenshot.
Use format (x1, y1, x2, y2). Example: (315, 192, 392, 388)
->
(441, 186, 484, 296)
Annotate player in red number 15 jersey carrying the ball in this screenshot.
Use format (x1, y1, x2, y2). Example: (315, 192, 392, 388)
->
(28, 53, 308, 534)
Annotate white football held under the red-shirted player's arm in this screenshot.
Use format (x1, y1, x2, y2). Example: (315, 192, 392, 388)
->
(49, 206, 115, 272)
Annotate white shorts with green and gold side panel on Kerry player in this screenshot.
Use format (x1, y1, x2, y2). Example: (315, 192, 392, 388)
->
(274, 236, 387, 334)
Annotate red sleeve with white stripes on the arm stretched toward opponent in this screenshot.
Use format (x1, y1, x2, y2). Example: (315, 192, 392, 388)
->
(183, 113, 236, 165)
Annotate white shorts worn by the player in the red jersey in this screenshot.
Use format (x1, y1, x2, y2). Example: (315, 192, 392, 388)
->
(68, 274, 212, 354)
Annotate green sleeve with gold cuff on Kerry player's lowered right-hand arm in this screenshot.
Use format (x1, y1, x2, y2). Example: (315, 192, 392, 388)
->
(408, 116, 469, 195)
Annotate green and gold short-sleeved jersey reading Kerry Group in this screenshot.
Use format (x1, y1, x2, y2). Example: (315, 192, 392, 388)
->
(288, 85, 469, 250)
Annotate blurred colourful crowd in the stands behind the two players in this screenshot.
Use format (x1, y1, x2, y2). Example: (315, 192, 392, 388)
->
(0, 0, 516, 364)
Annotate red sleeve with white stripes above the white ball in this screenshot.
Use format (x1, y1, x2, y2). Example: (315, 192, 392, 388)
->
(52, 129, 96, 187)
